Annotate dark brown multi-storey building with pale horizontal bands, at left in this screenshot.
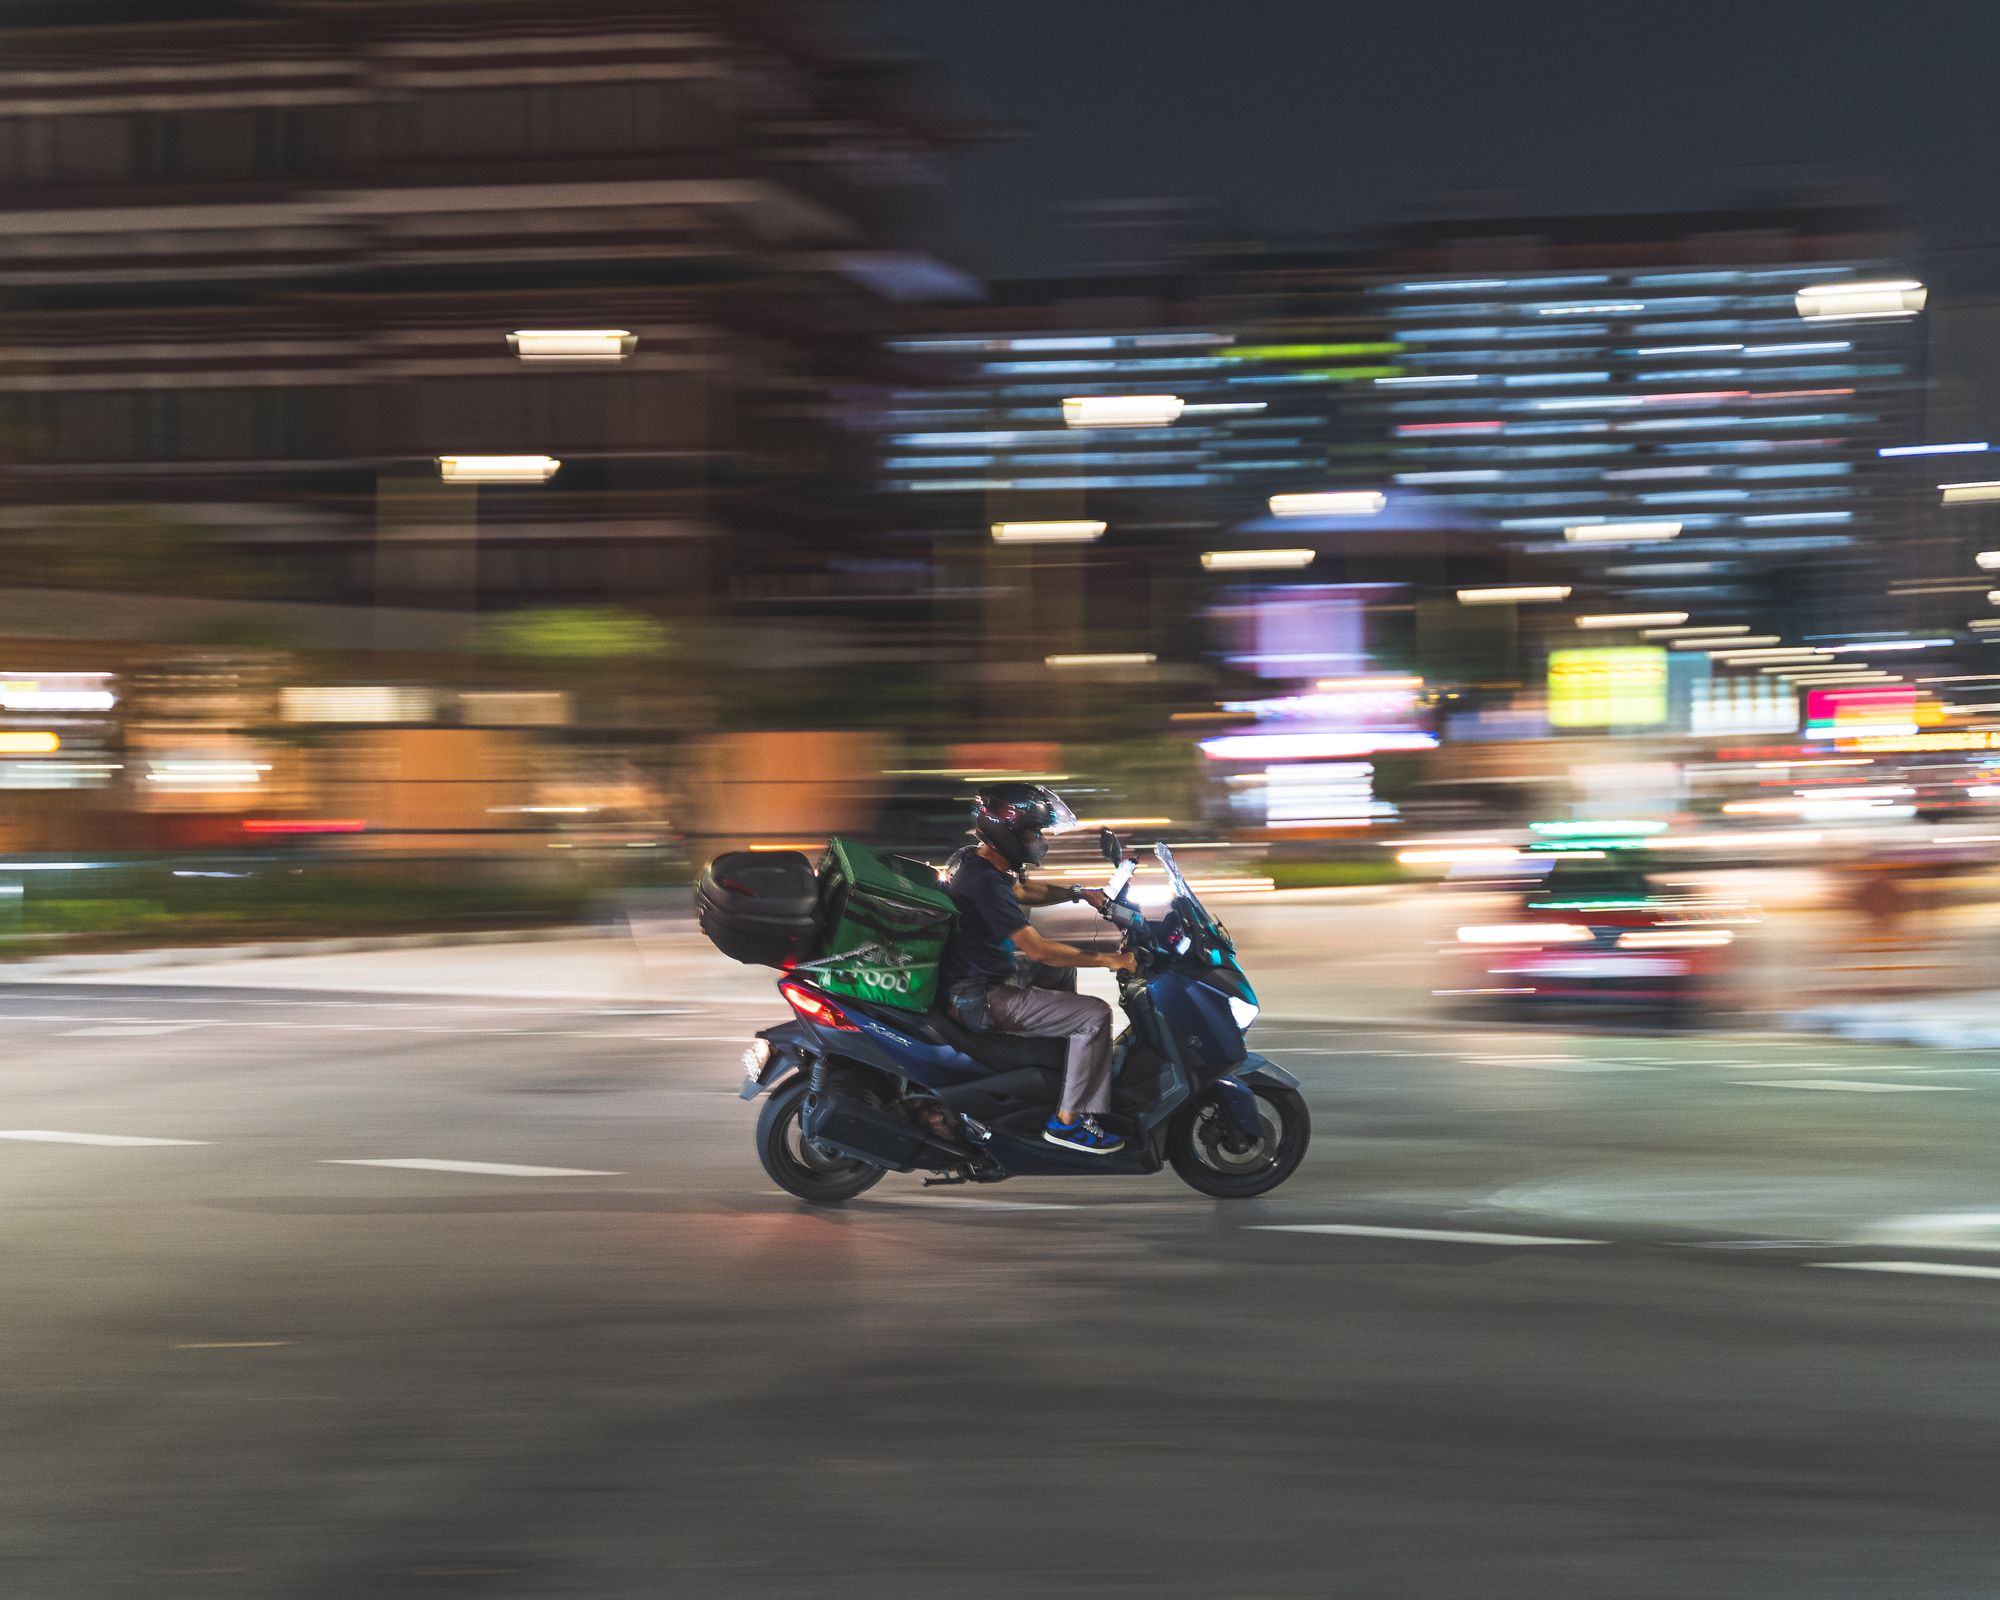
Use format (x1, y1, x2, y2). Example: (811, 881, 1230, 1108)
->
(0, 0, 950, 612)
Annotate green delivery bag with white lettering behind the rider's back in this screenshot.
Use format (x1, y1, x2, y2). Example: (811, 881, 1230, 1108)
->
(802, 838, 954, 1012)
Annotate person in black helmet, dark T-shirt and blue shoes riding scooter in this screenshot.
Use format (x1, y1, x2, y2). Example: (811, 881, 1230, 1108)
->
(940, 784, 1138, 1156)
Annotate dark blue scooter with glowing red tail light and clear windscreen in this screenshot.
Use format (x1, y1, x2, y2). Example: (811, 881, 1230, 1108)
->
(740, 828, 1312, 1204)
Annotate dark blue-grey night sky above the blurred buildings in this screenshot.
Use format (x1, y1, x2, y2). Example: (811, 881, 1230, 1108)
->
(848, 0, 2000, 276)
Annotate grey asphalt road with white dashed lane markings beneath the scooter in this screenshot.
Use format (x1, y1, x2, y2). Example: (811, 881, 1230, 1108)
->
(11, 984, 2000, 1600)
